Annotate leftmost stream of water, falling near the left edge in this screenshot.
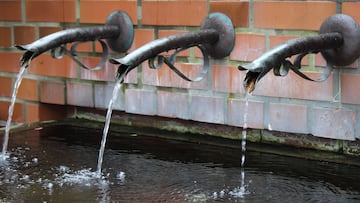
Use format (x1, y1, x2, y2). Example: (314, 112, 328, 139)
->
(0, 65, 27, 160)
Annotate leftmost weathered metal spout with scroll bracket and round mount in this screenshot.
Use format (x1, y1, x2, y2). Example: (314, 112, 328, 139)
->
(16, 11, 134, 69)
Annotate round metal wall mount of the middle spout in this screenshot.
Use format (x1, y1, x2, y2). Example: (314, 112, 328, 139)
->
(201, 13, 235, 58)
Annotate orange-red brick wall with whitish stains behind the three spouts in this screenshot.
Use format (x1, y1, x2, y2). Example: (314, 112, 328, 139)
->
(0, 0, 360, 140)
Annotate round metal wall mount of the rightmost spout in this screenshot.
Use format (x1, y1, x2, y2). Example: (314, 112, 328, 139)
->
(320, 14, 360, 66)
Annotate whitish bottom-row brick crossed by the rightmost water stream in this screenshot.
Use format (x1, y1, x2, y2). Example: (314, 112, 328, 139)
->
(228, 99, 264, 129)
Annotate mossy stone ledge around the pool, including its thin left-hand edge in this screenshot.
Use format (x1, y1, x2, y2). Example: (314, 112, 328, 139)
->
(0, 107, 360, 166)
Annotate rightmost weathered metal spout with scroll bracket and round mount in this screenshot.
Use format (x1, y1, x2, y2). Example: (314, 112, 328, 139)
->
(238, 14, 360, 93)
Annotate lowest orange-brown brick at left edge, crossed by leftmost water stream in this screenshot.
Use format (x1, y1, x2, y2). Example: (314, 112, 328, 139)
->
(0, 101, 25, 123)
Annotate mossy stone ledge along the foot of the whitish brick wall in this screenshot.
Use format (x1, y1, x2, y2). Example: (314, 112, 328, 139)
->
(70, 108, 360, 158)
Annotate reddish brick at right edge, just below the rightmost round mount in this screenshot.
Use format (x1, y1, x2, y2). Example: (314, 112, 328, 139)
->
(341, 73, 360, 104)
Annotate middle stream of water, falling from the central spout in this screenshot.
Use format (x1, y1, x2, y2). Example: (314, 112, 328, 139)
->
(97, 80, 122, 177)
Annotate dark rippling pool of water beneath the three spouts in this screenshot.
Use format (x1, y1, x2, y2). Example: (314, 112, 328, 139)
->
(0, 126, 360, 202)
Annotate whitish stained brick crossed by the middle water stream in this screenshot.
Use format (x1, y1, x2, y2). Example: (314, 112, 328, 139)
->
(94, 83, 125, 111)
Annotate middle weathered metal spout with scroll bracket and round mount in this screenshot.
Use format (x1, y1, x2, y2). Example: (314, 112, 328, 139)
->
(110, 13, 235, 81)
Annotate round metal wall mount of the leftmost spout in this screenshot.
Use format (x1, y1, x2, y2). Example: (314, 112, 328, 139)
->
(106, 11, 134, 53)
